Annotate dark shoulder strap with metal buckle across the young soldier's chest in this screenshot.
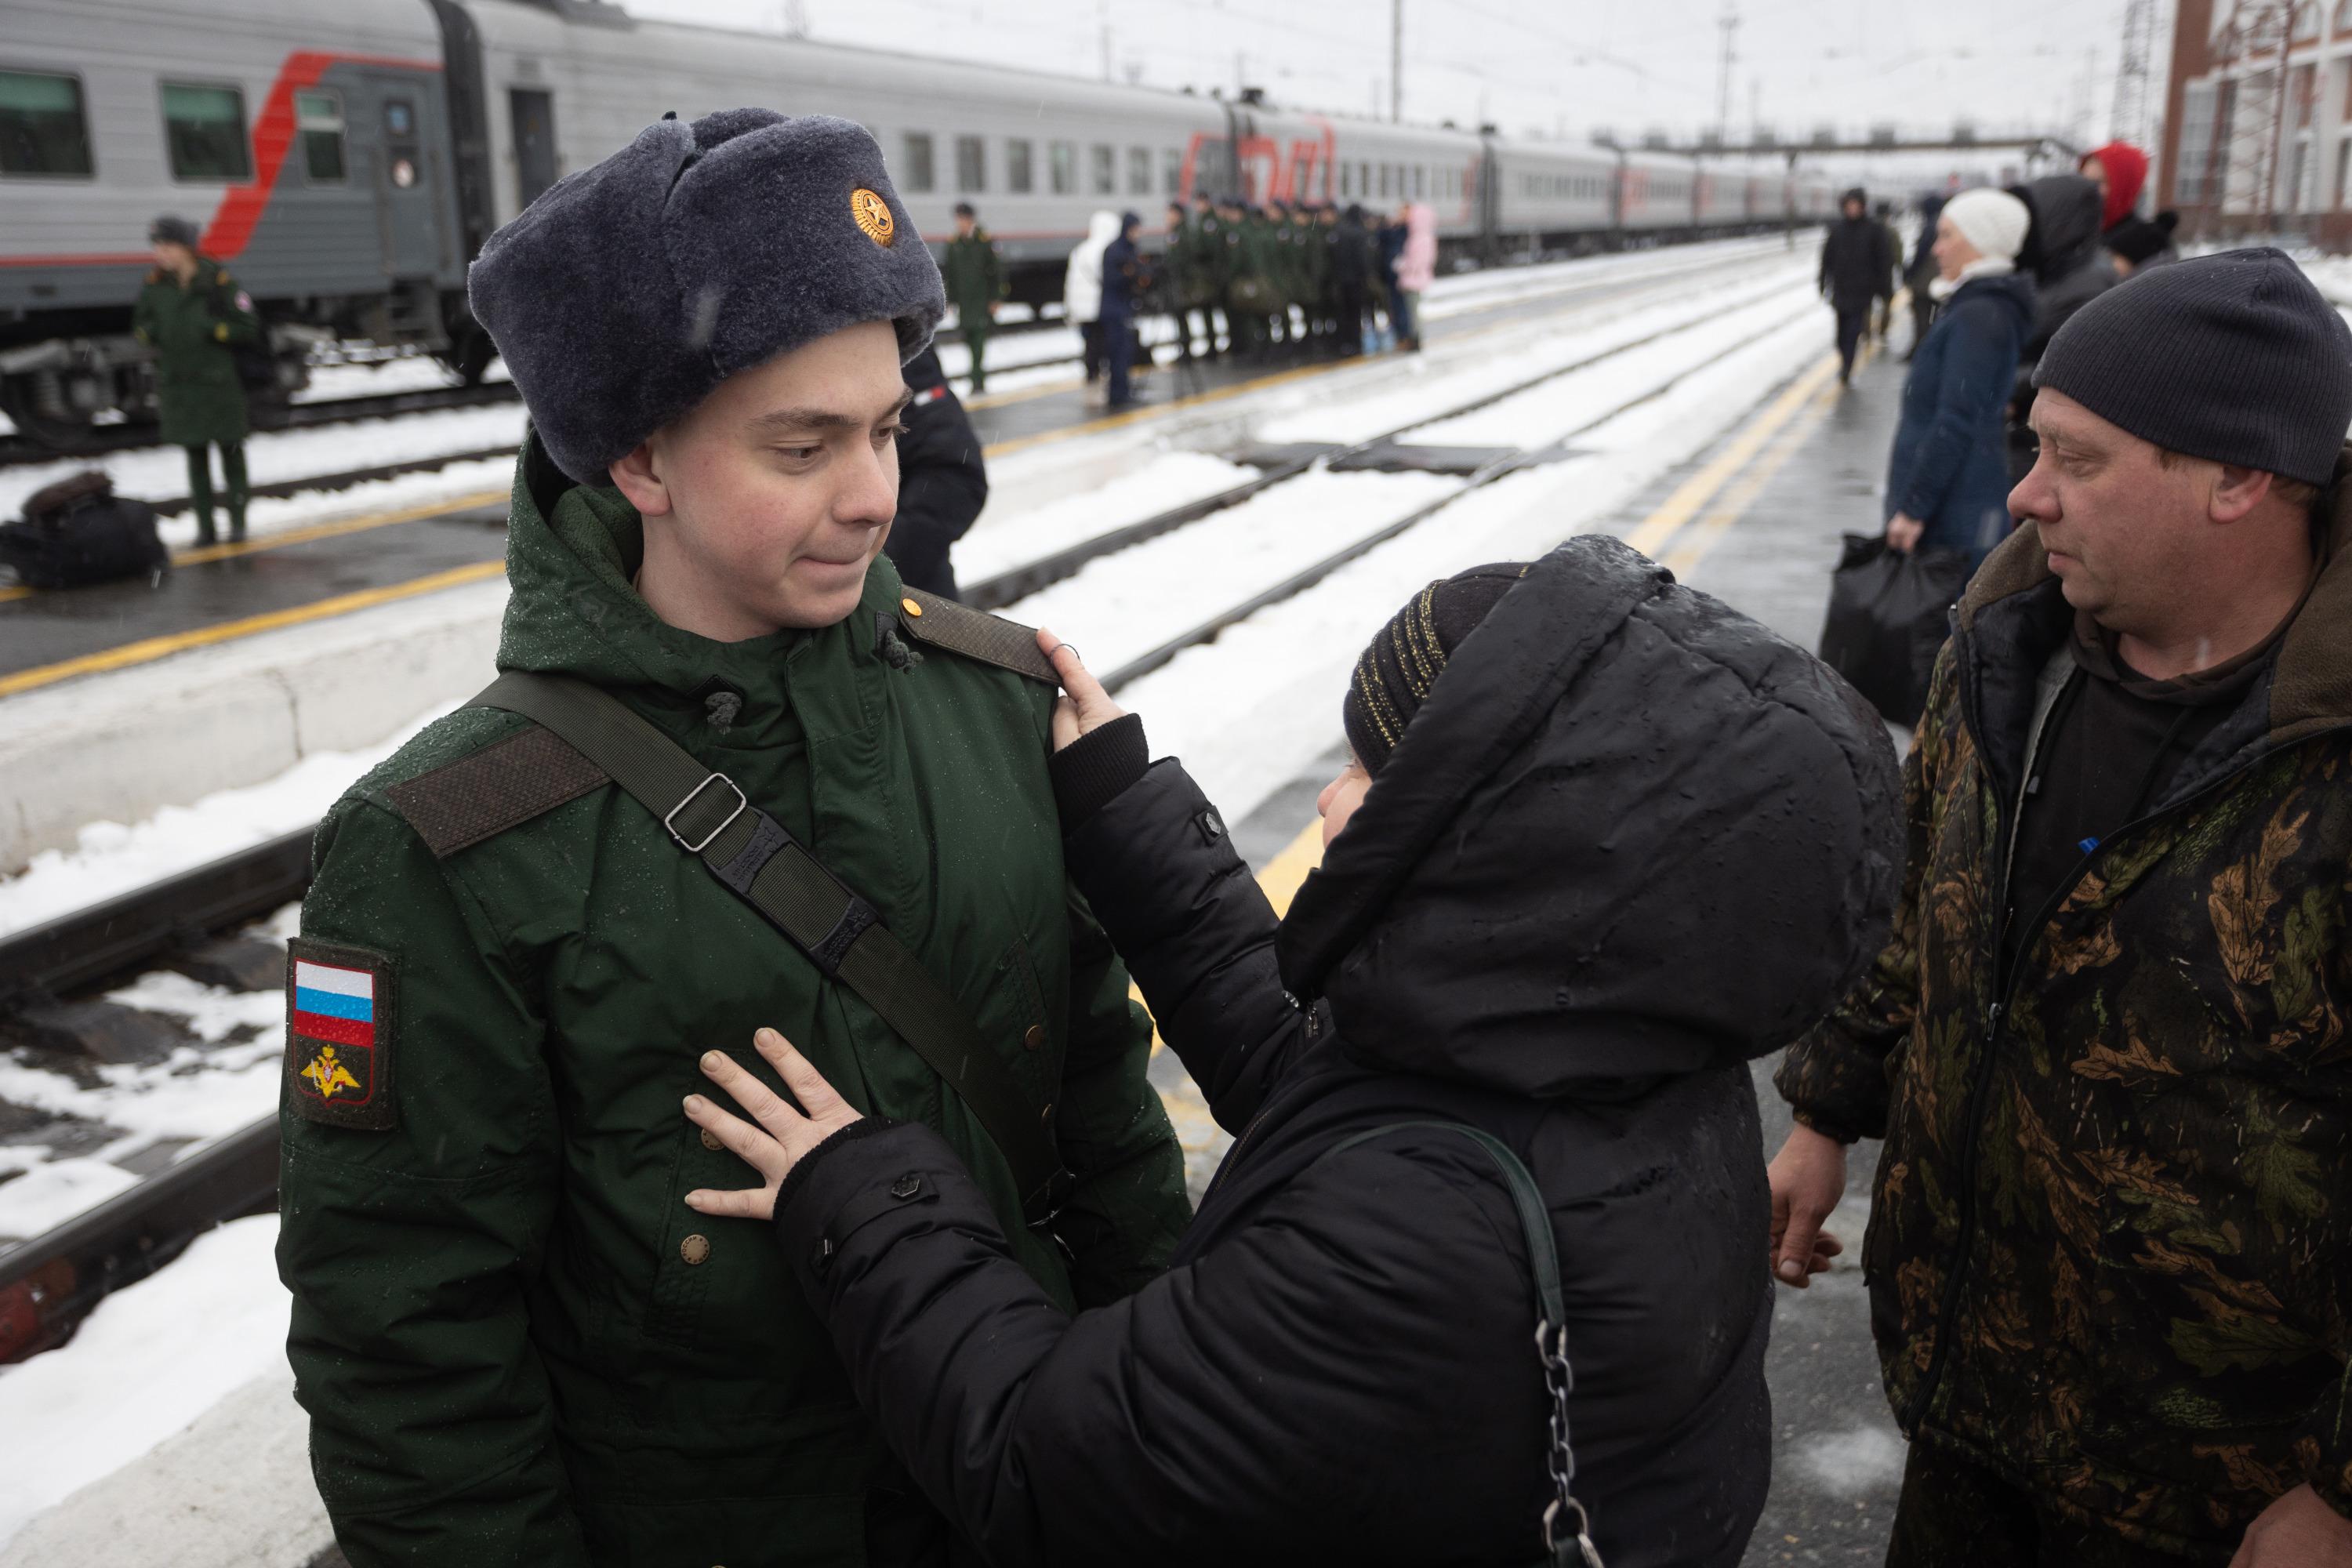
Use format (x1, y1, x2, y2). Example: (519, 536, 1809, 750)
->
(470, 673, 1073, 1225)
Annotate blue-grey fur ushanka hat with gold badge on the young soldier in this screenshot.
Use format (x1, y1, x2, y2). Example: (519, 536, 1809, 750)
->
(466, 108, 948, 485)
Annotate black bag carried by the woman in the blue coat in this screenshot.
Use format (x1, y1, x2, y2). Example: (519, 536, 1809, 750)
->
(1820, 534, 1969, 727)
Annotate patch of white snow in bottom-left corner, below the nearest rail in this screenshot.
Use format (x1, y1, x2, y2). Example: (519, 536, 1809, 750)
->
(0, 1215, 289, 1547)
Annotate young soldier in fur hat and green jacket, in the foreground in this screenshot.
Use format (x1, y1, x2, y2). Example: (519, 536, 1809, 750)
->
(278, 108, 1188, 1568)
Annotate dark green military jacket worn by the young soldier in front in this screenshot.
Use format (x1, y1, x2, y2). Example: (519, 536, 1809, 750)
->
(278, 440, 1188, 1568)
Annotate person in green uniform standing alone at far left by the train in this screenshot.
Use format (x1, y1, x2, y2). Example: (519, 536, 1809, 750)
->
(132, 216, 263, 546)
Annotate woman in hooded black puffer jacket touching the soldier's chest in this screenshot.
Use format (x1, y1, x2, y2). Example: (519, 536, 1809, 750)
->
(689, 539, 1900, 1568)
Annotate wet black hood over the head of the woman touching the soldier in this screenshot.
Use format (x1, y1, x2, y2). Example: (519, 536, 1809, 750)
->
(1277, 539, 1903, 1095)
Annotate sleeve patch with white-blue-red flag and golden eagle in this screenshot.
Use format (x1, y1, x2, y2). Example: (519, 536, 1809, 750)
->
(287, 940, 400, 1133)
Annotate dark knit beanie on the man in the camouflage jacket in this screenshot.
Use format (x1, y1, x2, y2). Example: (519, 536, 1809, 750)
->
(2034, 247, 2352, 485)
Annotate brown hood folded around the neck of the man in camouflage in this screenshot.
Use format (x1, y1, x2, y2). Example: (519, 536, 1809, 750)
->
(1959, 442, 2352, 757)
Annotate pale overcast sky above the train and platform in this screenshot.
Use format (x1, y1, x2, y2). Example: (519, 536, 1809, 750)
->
(621, 0, 2136, 141)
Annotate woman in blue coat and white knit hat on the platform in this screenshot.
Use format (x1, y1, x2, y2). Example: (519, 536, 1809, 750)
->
(1886, 191, 2034, 569)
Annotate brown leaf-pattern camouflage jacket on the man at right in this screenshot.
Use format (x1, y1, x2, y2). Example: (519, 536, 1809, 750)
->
(1778, 486, 2352, 1563)
